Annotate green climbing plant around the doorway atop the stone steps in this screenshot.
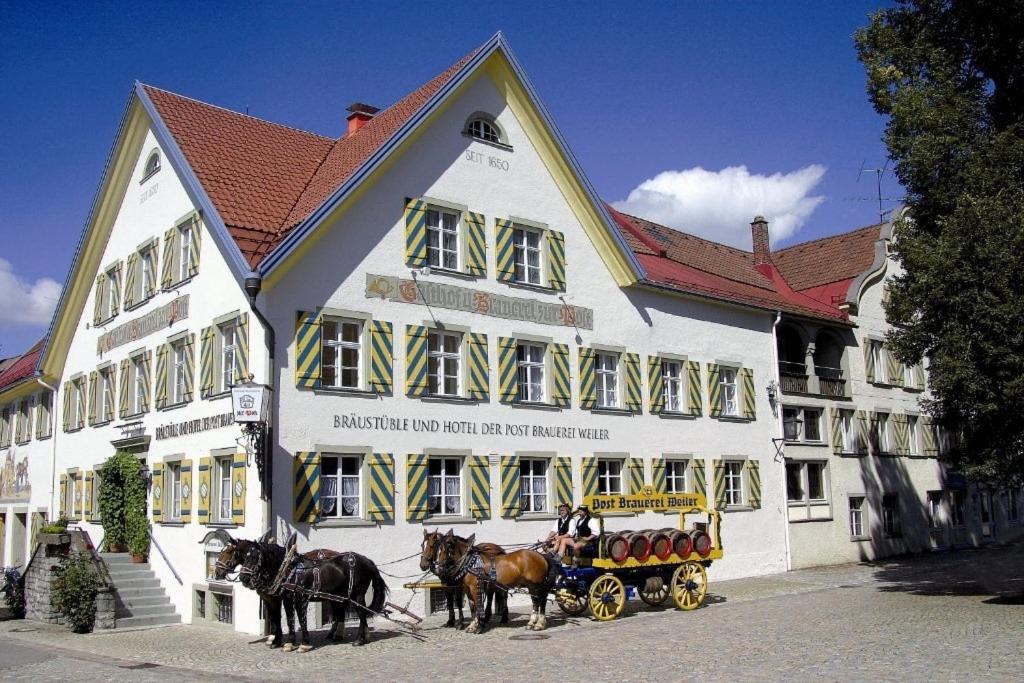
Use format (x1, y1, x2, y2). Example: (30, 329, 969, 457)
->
(96, 451, 148, 548)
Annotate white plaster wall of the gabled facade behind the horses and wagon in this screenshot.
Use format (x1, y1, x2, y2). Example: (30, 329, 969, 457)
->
(267, 69, 785, 608)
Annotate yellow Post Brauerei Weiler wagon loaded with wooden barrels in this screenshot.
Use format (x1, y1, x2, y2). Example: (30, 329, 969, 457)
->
(554, 487, 722, 622)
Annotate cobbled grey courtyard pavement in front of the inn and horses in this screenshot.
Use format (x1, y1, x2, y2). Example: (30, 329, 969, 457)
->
(0, 546, 1024, 681)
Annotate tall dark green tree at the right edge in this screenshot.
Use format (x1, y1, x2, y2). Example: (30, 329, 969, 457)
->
(855, 0, 1024, 483)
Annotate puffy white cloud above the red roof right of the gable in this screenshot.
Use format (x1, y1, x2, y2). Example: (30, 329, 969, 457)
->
(612, 164, 825, 250)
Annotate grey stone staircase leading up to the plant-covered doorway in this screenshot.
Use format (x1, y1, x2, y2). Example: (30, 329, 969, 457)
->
(99, 553, 181, 629)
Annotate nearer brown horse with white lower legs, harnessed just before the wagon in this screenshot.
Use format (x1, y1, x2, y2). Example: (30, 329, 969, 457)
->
(437, 531, 561, 633)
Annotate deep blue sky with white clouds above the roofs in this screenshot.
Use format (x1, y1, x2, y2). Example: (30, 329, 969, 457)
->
(0, 0, 900, 357)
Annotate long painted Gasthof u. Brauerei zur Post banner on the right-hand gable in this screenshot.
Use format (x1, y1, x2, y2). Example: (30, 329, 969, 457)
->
(367, 273, 594, 330)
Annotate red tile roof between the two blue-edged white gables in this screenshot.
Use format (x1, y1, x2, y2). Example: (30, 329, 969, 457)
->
(143, 50, 476, 266)
